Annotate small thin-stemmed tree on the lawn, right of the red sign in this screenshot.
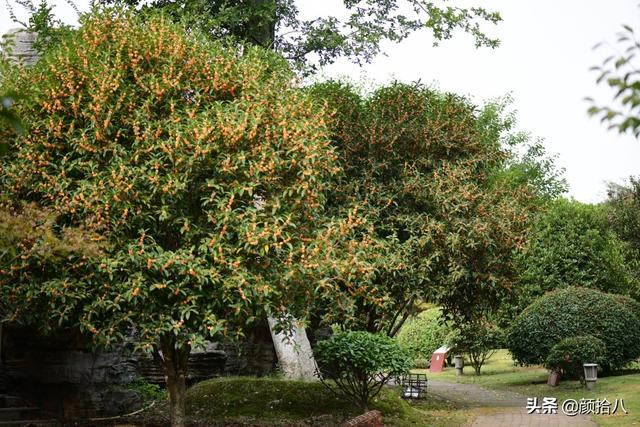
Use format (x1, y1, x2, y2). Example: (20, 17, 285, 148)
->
(447, 320, 502, 375)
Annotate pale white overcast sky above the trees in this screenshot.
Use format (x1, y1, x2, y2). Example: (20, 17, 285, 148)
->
(0, 0, 640, 202)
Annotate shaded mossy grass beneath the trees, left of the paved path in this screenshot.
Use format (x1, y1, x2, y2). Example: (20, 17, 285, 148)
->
(120, 377, 468, 427)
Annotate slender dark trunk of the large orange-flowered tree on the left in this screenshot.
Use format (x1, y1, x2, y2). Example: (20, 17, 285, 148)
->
(160, 337, 191, 427)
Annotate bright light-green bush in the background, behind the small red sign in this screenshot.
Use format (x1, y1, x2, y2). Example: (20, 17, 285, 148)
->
(396, 308, 451, 360)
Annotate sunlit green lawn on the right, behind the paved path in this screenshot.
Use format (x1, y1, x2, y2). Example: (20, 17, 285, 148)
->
(416, 350, 640, 426)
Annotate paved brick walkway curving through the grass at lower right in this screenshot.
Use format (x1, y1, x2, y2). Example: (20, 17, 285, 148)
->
(429, 379, 597, 427)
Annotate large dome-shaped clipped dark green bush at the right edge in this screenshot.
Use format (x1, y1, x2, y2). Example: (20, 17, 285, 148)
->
(506, 287, 640, 369)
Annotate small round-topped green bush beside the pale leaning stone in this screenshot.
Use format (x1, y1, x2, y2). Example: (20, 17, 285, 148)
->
(314, 331, 412, 412)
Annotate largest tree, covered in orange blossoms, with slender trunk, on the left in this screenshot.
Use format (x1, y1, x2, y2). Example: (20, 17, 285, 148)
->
(0, 10, 372, 426)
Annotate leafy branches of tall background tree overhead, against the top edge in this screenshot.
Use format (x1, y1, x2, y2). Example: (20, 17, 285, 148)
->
(100, 0, 501, 71)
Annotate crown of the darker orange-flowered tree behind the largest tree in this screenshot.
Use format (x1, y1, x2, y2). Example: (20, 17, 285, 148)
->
(309, 82, 532, 335)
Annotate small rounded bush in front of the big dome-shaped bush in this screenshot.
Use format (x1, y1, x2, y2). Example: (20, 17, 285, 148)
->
(545, 335, 607, 381)
